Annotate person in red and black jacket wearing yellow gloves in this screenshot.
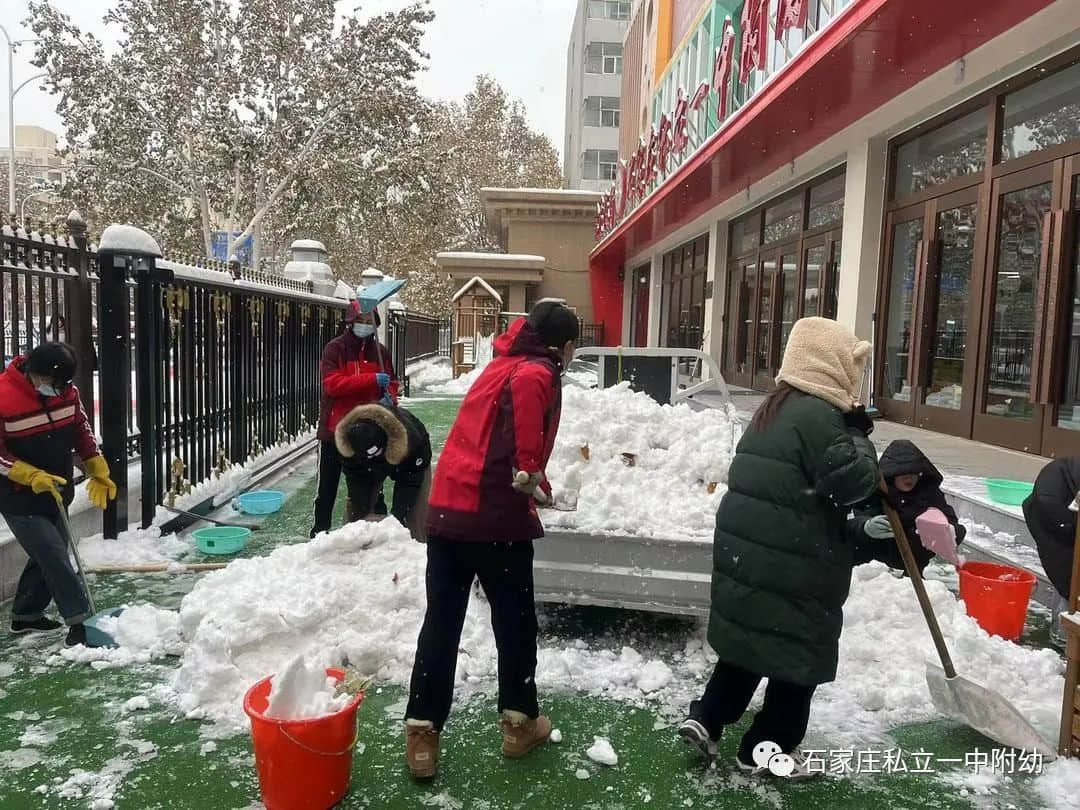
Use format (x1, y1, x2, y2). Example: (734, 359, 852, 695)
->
(0, 343, 117, 647)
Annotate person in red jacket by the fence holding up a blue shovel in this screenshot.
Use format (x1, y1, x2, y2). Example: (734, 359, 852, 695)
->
(311, 301, 397, 537)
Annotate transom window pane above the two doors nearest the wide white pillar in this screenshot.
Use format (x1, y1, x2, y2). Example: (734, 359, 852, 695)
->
(895, 109, 987, 197)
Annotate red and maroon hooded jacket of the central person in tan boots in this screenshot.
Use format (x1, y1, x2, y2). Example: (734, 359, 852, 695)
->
(428, 318, 563, 541)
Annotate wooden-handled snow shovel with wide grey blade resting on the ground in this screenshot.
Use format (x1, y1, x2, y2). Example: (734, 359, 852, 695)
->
(882, 498, 1057, 760)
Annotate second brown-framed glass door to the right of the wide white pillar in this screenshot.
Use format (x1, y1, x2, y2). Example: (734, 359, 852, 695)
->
(915, 189, 978, 435)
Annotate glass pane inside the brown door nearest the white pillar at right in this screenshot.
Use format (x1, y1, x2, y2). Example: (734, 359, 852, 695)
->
(881, 219, 922, 402)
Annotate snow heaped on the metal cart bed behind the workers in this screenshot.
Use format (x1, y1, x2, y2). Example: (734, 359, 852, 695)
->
(543, 382, 741, 540)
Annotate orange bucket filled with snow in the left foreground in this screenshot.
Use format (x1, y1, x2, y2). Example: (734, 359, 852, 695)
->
(244, 670, 364, 810)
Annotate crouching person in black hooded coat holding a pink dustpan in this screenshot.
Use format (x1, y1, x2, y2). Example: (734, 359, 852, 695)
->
(878, 438, 968, 573)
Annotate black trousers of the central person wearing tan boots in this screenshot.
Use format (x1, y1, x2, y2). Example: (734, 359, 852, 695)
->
(405, 538, 540, 730)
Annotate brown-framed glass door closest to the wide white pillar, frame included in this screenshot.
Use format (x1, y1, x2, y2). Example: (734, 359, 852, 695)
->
(876, 205, 926, 424)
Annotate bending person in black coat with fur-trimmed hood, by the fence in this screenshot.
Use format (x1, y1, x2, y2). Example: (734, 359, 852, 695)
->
(334, 403, 431, 541)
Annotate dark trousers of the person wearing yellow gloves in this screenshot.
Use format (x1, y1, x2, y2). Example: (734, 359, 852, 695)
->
(3, 514, 90, 624)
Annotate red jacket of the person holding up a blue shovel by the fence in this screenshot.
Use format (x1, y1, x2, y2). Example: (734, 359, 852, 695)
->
(319, 330, 397, 442)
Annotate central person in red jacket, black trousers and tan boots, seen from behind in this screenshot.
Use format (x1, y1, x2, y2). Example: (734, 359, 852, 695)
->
(405, 300, 578, 779)
